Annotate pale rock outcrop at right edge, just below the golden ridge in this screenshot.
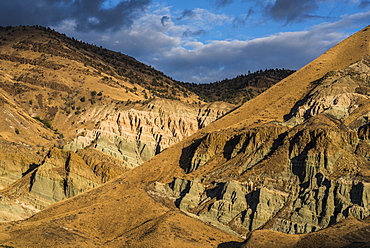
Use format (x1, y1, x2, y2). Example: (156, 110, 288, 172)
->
(287, 57, 370, 123)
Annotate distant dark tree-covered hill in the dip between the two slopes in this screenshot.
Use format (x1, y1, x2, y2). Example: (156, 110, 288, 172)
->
(182, 69, 294, 104)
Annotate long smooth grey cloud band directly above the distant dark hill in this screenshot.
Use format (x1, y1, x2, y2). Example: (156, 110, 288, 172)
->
(150, 12, 370, 82)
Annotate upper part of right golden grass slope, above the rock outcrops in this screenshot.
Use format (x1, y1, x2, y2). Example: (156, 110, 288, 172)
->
(204, 24, 370, 132)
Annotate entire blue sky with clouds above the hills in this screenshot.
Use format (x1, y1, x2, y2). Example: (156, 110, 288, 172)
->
(0, 0, 370, 83)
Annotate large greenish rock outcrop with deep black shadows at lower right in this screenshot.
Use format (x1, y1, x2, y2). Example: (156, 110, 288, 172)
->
(163, 113, 370, 235)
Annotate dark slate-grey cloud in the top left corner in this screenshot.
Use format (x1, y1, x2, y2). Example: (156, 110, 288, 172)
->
(0, 0, 150, 31)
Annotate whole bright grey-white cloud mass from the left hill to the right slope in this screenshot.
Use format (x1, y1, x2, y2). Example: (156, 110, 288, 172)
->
(52, 7, 370, 83)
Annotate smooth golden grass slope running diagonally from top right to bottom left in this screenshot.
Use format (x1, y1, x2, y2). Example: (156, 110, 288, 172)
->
(0, 27, 370, 247)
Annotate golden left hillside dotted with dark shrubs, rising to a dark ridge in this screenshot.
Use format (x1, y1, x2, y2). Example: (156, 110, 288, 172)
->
(0, 27, 202, 140)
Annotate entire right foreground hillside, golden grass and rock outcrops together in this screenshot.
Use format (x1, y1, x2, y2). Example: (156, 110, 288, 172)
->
(0, 27, 370, 247)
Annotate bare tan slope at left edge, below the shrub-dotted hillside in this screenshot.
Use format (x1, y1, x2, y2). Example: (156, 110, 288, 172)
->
(0, 85, 54, 194)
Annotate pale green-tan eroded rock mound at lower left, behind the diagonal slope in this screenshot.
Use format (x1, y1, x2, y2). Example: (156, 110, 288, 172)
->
(0, 148, 128, 221)
